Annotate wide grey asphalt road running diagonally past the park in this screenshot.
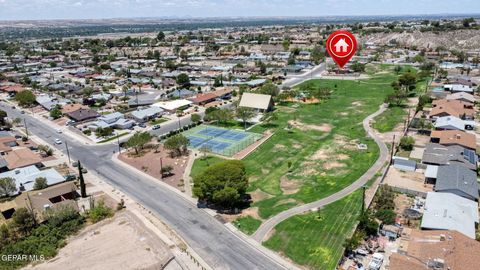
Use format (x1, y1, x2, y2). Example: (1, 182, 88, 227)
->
(0, 103, 285, 270)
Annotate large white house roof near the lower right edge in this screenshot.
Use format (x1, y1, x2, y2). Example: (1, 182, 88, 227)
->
(421, 192, 478, 239)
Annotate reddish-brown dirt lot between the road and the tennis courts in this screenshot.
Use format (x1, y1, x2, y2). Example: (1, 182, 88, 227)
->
(118, 146, 188, 191)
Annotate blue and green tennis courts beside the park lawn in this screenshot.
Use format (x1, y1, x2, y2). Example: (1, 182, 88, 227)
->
(184, 125, 262, 156)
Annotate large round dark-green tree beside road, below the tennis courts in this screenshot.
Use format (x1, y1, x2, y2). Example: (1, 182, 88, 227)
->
(193, 160, 248, 209)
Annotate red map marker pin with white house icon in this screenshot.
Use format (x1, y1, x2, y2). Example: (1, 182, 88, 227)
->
(327, 30, 357, 68)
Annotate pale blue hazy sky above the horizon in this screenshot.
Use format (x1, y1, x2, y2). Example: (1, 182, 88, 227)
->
(0, 0, 480, 20)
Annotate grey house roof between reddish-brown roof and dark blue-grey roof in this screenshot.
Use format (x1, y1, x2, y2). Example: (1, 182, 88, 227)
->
(422, 143, 477, 170)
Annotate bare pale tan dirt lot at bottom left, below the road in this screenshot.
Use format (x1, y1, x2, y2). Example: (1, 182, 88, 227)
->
(27, 211, 173, 270)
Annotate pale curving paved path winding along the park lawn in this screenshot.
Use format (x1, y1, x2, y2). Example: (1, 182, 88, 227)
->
(252, 104, 388, 243)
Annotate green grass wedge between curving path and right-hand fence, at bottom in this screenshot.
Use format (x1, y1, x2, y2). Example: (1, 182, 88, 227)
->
(263, 190, 362, 270)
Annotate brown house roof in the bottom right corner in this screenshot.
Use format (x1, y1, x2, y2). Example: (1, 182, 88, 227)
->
(389, 229, 480, 270)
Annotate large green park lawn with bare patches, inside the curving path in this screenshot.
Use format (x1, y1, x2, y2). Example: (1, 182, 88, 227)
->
(244, 70, 402, 219)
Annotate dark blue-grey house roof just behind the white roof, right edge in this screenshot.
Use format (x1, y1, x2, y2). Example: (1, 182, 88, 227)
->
(435, 164, 479, 200)
